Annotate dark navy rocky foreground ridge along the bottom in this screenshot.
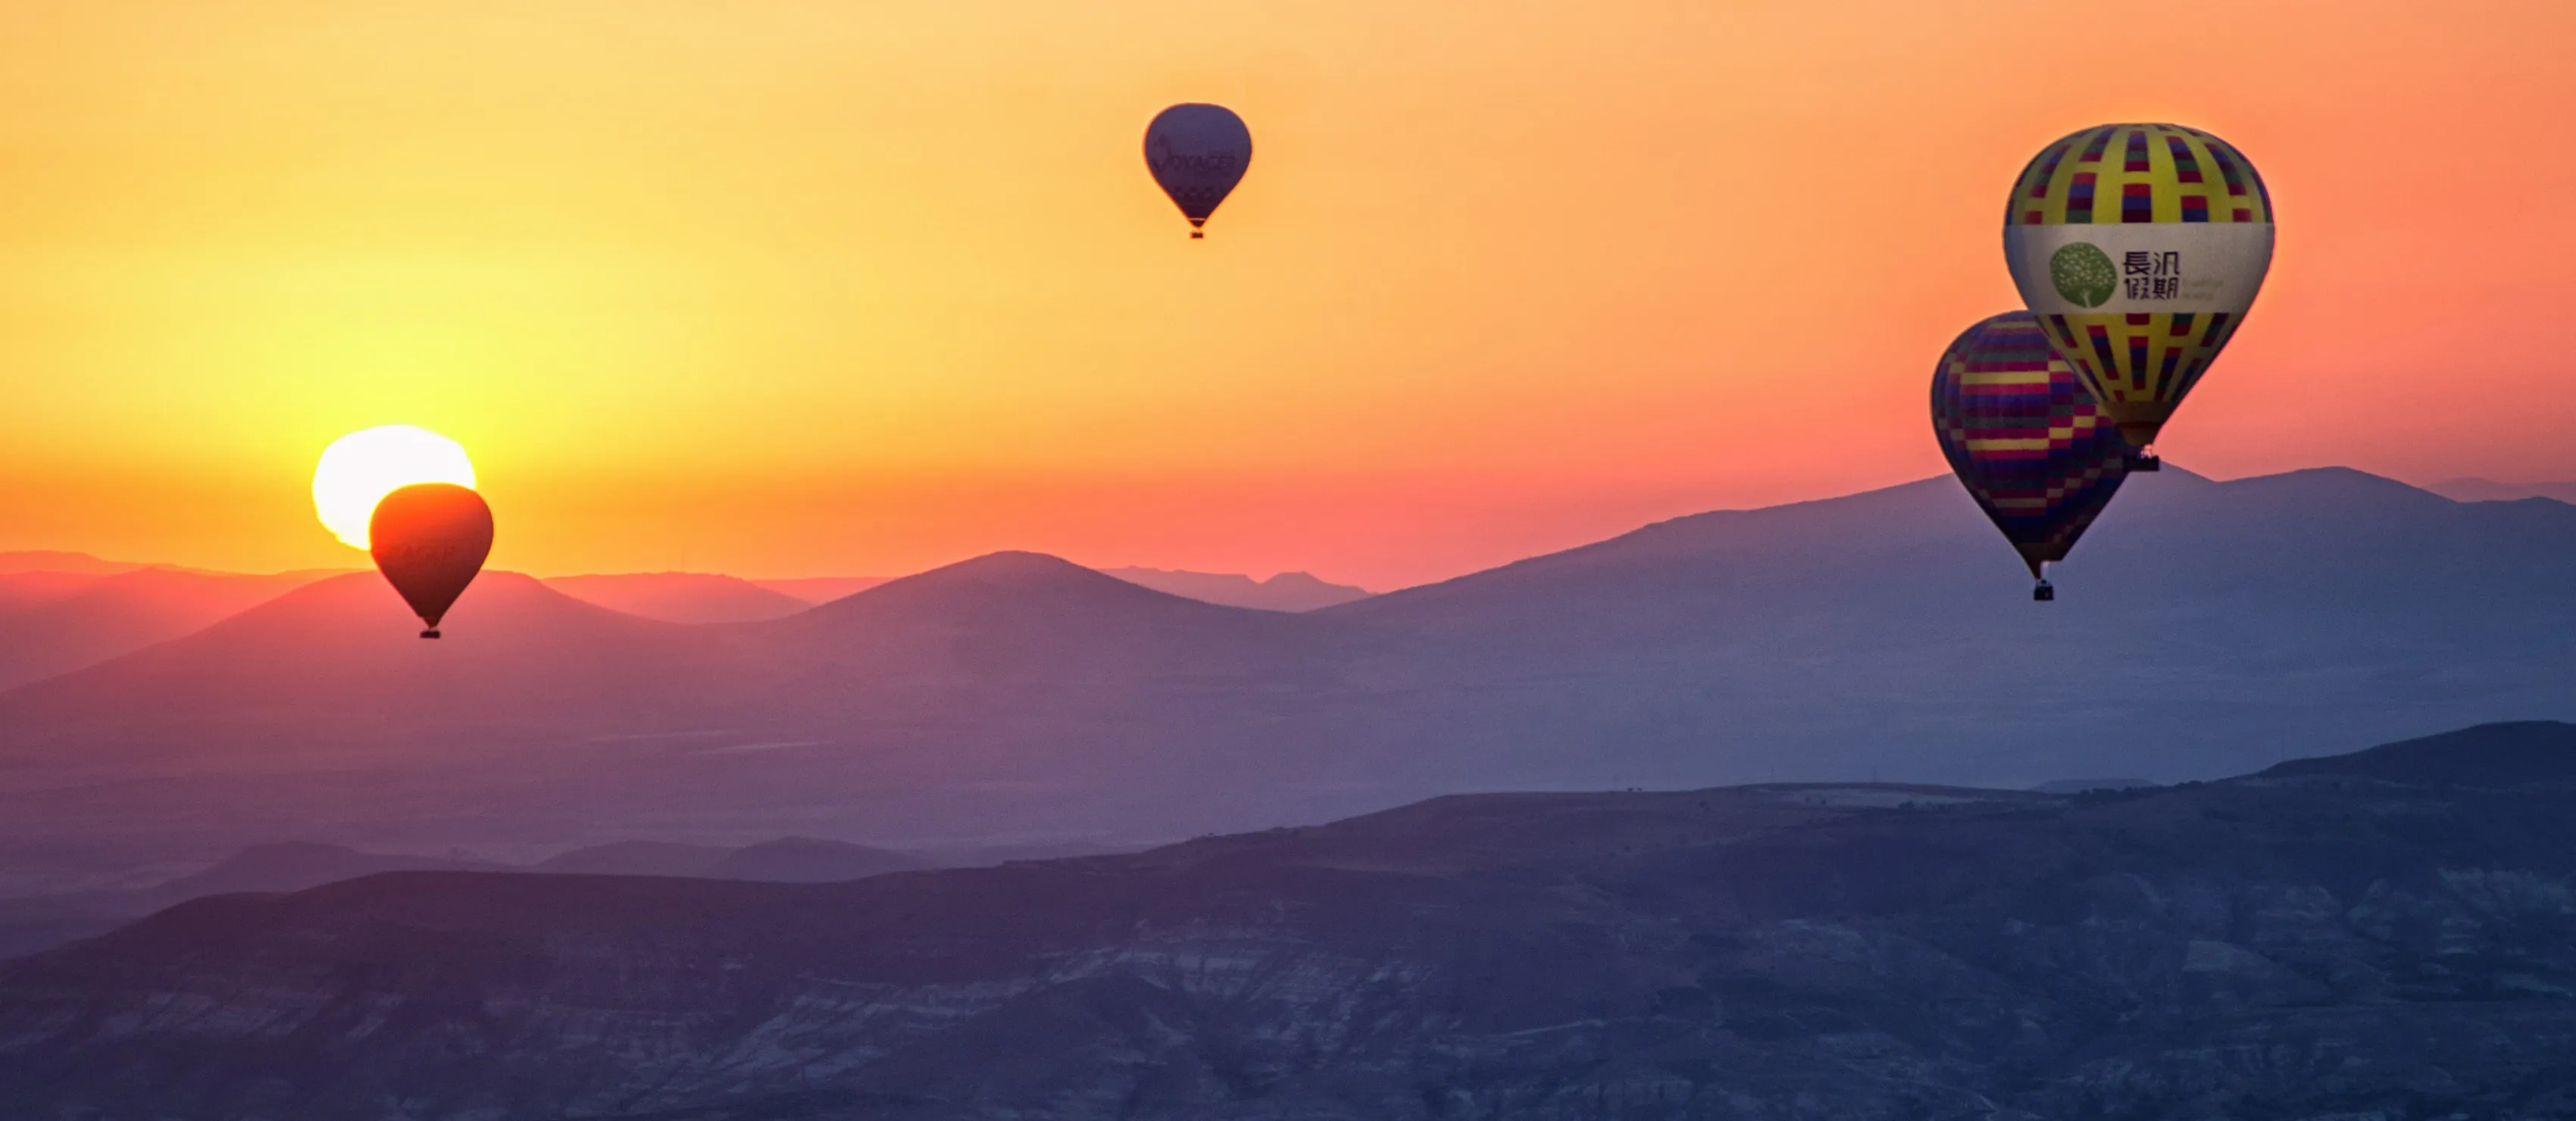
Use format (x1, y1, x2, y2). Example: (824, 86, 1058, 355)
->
(0, 724, 2576, 1121)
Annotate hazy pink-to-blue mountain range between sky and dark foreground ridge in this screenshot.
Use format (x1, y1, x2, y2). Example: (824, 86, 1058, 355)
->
(0, 469, 2576, 889)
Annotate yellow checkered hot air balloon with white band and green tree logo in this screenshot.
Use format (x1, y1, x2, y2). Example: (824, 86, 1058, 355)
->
(2004, 123, 2272, 472)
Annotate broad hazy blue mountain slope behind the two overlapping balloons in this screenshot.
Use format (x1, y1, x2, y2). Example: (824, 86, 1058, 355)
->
(1316, 469, 2576, 786)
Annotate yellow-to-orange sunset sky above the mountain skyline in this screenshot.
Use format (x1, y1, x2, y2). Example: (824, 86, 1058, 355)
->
(0, 0, 2576, 588)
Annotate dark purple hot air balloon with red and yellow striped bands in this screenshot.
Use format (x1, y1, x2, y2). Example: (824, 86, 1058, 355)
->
(1932, 312, 2127, 601)
